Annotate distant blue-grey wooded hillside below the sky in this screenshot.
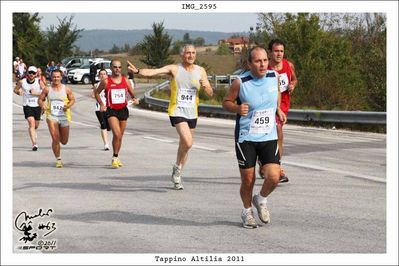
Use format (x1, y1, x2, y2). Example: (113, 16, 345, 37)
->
(75, 29, 248, 51)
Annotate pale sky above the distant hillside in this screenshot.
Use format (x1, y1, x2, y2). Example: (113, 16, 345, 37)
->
(39, 12, 258, 32)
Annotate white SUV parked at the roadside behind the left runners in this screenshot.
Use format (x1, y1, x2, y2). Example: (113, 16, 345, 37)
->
(68, 60, 112, 84)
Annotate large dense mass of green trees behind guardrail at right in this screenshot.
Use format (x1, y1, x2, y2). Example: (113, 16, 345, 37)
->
(250, 13, 386, 110)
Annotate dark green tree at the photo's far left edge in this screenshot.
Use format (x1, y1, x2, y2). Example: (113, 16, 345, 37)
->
(12, 13, 47, 66)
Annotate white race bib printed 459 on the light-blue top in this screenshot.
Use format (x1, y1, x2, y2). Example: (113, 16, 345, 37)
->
(249, 108, 275, 134)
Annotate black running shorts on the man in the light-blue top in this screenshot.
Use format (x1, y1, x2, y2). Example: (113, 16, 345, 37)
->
(236, 140, 280, 169)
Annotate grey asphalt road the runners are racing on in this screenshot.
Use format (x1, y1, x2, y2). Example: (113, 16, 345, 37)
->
(12, 85, 387, 260)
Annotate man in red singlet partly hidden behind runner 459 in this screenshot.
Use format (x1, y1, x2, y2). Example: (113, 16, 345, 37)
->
(268, 39, 298, 183)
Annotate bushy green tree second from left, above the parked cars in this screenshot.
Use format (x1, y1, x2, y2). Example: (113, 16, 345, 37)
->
(46, 16, 83, 61)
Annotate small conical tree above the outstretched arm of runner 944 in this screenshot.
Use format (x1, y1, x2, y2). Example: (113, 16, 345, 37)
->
(140, 22, 173, 68)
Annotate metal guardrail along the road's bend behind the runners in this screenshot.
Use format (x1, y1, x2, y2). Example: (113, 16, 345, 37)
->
(144, 79, 386, 125)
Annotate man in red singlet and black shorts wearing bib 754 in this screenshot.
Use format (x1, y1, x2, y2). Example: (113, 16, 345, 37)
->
(95, 60, 139, 168)
